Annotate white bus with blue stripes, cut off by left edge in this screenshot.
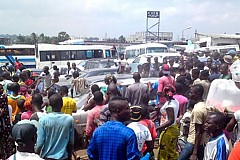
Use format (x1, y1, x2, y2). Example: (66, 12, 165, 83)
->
(0, 44, 36, 68)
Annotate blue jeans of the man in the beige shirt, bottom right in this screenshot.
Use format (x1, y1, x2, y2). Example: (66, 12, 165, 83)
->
(178, 142, 204, 160)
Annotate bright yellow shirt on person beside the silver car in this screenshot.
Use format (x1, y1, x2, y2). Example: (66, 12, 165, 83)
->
(61, 97, 77, 115)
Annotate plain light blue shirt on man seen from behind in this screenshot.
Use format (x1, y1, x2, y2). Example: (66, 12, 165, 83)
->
(38, 112, 74, 159)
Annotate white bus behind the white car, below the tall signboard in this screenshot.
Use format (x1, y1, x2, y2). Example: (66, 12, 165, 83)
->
(125, 43, 168, 63)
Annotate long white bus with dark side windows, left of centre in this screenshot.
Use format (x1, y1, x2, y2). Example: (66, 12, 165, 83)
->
(36, 44, 115, 68)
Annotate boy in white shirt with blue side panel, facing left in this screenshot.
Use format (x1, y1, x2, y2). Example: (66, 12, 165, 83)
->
(204, 112, 229, 160)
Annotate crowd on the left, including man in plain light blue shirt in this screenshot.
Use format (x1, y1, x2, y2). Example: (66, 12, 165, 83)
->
(0, 62, 79, 160)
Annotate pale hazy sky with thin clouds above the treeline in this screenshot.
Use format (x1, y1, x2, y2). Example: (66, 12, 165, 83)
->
(0, 0, 240, 40)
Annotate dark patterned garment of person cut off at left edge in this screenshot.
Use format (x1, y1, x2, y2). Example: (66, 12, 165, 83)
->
(0, 85, 13, 159)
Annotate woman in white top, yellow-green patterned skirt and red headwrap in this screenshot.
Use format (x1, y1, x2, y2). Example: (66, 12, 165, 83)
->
(156, 86, 179, 160)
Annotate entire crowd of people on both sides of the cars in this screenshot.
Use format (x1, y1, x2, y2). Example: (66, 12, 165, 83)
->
(0, 51, 240, 160)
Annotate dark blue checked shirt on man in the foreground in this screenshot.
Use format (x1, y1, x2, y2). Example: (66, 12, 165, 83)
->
(87, 121, 140, 160)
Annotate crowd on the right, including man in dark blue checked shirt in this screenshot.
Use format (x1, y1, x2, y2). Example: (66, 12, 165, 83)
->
(85, 51, 240, 160)
